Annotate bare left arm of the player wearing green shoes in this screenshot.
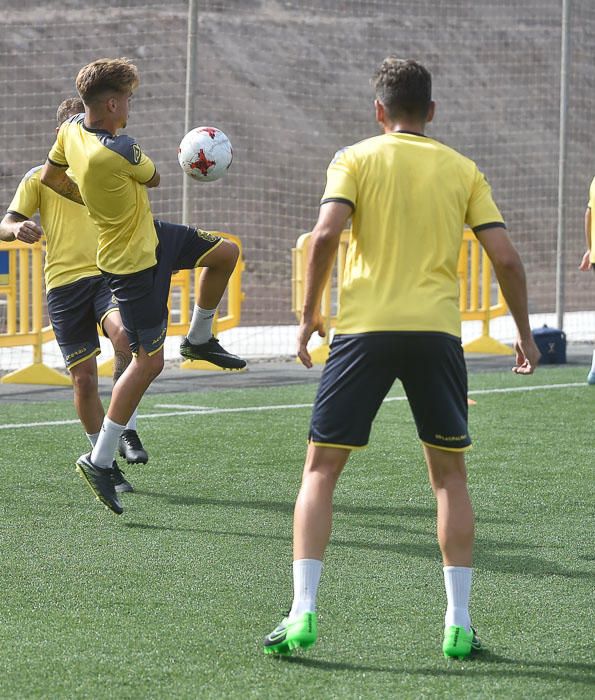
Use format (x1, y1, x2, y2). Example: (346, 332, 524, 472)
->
(297, 202, 352, 367)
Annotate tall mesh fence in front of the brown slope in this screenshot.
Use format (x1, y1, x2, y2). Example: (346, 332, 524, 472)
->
(0, 0, 595, 360)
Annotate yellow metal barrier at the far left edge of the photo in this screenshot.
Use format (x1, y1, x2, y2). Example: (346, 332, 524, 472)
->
(0, 241, 71, 386)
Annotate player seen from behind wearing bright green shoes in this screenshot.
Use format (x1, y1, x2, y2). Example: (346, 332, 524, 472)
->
(264, 57, 539, 657)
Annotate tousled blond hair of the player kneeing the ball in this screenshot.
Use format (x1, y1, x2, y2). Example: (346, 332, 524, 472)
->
(76, 58, 139, 105)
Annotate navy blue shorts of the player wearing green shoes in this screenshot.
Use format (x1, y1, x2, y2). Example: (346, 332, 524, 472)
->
(310, 331, 471, 450)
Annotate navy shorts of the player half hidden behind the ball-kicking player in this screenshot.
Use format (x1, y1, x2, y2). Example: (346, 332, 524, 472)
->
(48, 275, 118, 369)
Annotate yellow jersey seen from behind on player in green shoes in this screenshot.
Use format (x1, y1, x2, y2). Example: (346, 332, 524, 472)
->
(322, 132, 505, 337)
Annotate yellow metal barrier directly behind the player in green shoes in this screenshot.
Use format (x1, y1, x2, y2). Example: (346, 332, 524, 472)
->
(291, 229, 513, 364)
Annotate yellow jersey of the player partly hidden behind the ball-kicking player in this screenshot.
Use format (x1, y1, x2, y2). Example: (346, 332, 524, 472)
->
(8, 165, 101, 292)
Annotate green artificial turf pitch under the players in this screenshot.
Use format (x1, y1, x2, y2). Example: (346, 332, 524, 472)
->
(0, 368, 595, 700)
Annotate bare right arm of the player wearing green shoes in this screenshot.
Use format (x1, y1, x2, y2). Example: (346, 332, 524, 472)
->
(477, 227, 541, 374)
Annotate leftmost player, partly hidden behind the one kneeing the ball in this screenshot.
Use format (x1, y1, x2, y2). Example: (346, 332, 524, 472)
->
(0, 97, 154, 491)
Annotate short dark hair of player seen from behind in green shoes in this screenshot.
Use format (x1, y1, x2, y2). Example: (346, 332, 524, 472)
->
(372, 56, 432, 119)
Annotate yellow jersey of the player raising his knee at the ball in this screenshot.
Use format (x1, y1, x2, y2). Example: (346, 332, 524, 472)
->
(48, 114, 157, 275)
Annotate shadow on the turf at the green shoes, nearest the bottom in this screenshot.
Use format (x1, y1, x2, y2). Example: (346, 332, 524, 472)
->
(278, 650, 595, 685)
